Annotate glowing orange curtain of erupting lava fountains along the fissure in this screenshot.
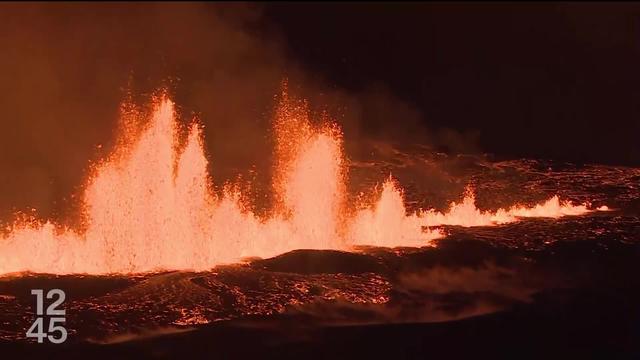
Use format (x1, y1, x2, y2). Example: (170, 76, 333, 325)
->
(0, 91, 591, 274)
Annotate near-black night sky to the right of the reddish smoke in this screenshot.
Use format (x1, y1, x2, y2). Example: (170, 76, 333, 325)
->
(266, 3, 640, 165)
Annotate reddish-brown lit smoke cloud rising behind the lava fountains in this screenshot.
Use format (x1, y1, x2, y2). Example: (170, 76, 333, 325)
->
(0, 3, 469, 224)
